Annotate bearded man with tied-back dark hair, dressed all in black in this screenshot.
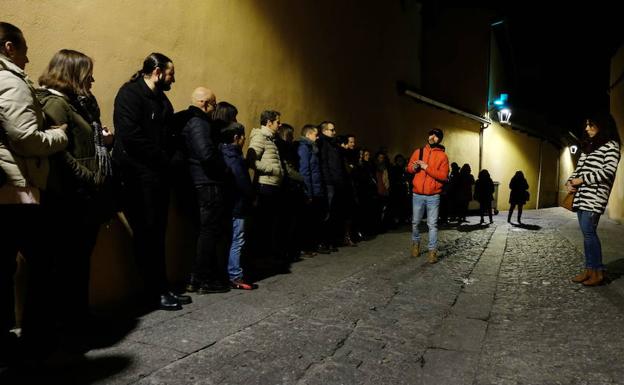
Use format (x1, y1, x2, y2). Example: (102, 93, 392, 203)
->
(113, 53, 191, 310)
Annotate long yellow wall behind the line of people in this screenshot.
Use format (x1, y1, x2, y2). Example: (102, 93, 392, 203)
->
(1, 0, 560, 303)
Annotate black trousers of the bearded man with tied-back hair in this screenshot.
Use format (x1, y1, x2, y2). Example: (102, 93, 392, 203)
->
(121, 170, 169, 296)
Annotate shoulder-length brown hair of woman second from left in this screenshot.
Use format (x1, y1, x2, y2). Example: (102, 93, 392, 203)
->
(39, 49, 93, 97)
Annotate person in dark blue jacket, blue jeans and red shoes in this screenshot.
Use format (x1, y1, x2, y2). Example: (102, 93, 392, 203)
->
(221, 122, 258, 290)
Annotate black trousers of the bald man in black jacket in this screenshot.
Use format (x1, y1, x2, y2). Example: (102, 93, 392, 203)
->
(192, 184, 232, 282)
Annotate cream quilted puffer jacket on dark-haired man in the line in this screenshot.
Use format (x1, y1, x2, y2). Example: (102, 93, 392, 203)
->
(247, 126, 284, 186)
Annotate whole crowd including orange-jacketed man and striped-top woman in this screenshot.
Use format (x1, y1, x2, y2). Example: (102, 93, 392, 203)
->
(0, 22, 619, 368)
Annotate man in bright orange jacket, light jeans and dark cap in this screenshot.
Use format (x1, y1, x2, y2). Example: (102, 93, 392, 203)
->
(406, 128, 449, 263)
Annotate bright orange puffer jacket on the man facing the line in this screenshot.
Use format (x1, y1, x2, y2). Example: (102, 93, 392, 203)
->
(405, 144, 449, 195)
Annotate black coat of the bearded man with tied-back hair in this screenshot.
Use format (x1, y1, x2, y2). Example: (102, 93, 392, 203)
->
(113, 78, 174, 180)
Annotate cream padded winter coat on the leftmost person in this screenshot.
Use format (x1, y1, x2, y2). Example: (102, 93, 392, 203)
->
(0, 55, 67, 204)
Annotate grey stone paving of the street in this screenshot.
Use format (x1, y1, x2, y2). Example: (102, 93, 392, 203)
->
(0, 208, 624, 385)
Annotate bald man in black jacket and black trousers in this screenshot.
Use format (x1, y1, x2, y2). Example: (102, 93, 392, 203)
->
(176, 87, 230, 294)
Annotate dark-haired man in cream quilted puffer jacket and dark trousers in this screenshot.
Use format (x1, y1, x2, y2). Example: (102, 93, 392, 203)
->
(247, 110, 286, 269)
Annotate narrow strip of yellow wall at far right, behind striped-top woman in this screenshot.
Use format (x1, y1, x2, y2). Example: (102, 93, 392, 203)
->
(607, 45, 624, 222)
